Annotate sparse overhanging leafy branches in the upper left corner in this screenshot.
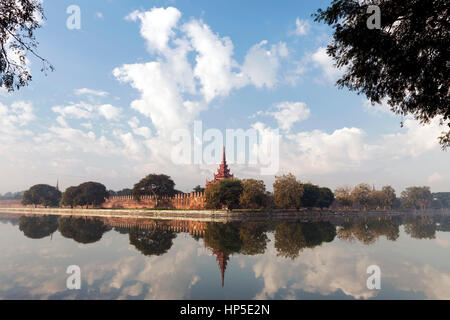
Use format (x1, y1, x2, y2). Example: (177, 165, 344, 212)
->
(0, 0, 53, 91)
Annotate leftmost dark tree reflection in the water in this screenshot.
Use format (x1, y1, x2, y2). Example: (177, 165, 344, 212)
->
(19, 216, 58, 239)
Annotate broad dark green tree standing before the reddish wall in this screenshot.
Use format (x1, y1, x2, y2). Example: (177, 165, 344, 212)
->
(133, 174, 175, 207)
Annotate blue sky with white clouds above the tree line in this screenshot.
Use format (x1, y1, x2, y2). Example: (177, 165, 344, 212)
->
(0, 0, 450, 194)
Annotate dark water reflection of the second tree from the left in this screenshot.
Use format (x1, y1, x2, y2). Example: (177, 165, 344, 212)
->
(58, 217, 110, 244)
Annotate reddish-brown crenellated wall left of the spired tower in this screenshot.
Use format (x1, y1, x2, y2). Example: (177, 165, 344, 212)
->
(102, 192, 206, 209)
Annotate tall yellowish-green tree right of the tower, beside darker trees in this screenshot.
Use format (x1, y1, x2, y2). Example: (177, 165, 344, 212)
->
(273, 173, 303, 210)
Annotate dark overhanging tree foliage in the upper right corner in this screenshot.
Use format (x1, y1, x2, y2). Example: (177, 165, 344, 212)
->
(313, 0, 450, 149)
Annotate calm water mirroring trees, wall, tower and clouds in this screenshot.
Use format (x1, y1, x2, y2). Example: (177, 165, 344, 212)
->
(0, 214, 450, 299)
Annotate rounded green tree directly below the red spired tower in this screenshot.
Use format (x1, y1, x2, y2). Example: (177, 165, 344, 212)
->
(205, 179, 243, 210)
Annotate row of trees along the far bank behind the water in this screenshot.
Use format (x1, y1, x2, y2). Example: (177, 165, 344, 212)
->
(22, 173, 450, 210)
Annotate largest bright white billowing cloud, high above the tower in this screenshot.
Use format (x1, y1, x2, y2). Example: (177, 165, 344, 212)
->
(113, 7, 288, 139)
